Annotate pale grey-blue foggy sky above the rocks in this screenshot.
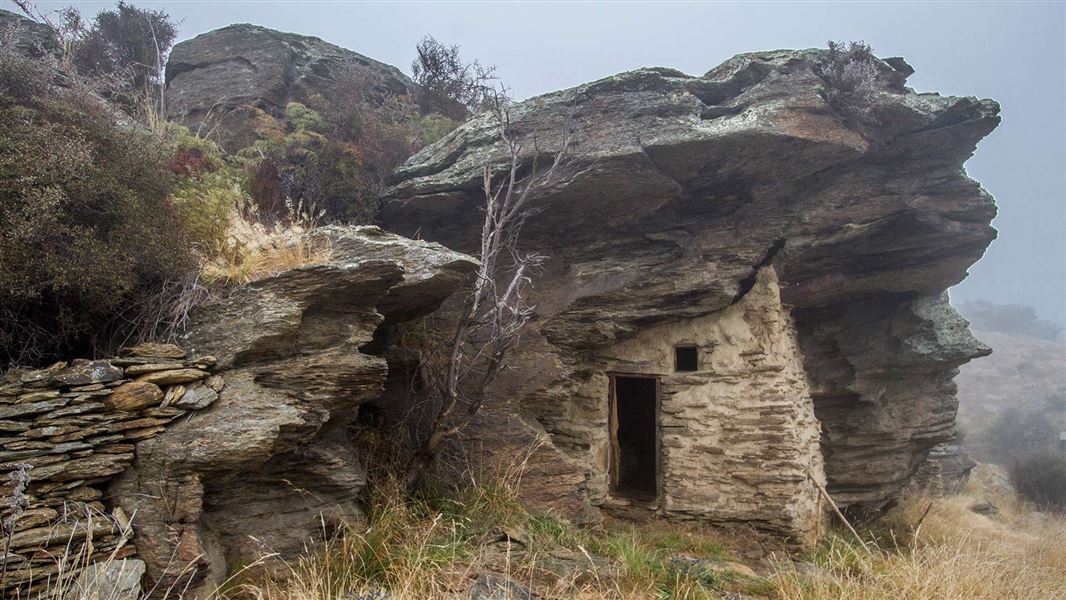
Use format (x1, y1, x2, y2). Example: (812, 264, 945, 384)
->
(31, 0, 1066, 323)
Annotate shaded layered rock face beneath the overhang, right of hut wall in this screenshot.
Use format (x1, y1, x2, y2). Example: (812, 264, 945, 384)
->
(794, 293, 990, 508)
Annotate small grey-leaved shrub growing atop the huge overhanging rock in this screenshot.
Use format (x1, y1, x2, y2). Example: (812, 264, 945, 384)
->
(814, 42, 883, 121)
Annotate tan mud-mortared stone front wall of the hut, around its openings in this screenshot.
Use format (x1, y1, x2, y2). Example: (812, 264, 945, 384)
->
(528, 267, 824, 545)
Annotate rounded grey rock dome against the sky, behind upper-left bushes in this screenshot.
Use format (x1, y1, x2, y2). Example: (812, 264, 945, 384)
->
(166, 23, 416, 150)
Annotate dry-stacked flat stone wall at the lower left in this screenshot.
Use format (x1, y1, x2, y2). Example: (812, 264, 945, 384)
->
(0, 343, 225, 595)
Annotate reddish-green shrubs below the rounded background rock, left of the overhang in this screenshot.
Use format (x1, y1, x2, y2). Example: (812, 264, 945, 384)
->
(239, 68, 458, 224)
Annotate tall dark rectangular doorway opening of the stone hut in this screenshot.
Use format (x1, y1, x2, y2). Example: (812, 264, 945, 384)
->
(611, 375, 659, 500)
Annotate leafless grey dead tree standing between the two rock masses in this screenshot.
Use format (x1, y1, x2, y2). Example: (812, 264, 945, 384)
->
(406, 92, 570, 490)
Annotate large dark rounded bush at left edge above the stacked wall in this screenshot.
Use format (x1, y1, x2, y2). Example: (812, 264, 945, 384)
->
(0, 48, 195, 363)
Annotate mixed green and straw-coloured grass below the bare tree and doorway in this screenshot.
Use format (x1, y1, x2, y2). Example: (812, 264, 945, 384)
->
(219, 451, 757, 600)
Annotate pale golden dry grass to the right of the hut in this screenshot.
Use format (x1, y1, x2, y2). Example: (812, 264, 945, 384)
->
(772, 466, 1066, 600)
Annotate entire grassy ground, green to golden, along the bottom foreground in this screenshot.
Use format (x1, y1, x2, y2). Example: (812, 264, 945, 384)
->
(224, 467, 1066, 600)
